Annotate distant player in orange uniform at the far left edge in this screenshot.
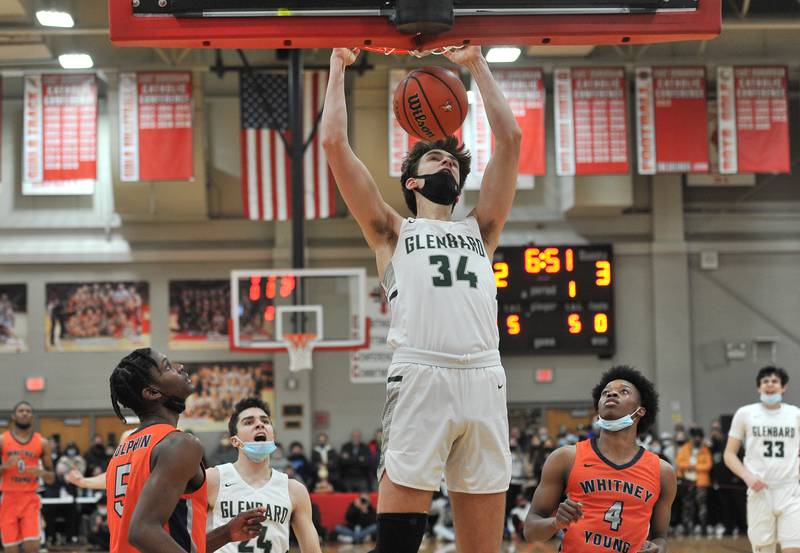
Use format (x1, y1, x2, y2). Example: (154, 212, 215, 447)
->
(0, 401, 55, 553)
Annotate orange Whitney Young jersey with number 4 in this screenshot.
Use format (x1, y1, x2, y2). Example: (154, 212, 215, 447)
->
(562, 439, 661, 553)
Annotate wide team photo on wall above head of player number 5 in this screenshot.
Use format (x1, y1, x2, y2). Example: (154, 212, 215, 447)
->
(44, 281, 150, 351)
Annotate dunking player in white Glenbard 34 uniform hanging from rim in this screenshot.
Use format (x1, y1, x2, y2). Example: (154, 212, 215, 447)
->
(321, 47, 521, 553)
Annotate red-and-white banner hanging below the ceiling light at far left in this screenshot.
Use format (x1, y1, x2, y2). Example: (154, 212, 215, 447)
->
(22, 74, 97, 195)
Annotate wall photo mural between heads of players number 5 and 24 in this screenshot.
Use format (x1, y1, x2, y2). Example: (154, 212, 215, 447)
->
(179, 361, 275, 432)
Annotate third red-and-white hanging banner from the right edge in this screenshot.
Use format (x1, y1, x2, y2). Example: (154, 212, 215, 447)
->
(554, 67, 629, 176)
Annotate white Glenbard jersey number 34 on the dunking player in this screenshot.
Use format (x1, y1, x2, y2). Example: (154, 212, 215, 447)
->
(383, 217, 500, 355)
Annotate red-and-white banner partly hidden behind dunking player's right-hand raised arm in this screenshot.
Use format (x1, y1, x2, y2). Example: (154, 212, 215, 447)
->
(465, 69, 547, 188)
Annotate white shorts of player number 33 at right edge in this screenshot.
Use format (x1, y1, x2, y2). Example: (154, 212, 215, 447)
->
(747, 481, 800, 552)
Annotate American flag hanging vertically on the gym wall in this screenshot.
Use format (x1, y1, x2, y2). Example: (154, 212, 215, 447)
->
(239, 71, 336, 221)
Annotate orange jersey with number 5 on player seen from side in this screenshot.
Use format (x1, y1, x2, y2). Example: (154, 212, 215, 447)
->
(106, 424, 208, 553)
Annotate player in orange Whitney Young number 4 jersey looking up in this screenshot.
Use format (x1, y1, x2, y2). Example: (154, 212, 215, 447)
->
(525, 366, 676, 553)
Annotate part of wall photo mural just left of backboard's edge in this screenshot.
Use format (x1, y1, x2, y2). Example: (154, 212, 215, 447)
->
(169, 280, 231, 350)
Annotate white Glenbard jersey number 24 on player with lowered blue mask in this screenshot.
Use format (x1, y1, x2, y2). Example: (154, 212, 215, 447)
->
(212, 463, 292, 553)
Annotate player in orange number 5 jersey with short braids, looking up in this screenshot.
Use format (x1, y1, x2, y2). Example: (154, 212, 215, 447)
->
(106, 348, 264, 553)
